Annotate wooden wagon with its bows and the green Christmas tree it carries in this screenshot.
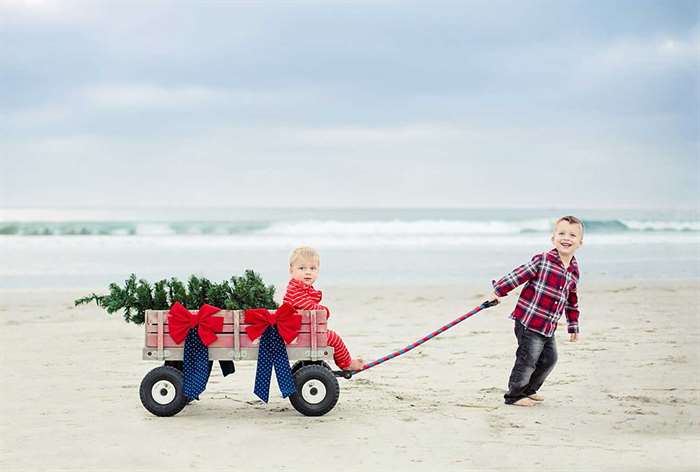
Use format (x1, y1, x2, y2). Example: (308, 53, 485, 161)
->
(75, 270, 343, 416)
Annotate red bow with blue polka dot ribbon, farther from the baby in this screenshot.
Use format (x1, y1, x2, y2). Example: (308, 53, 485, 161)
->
(168, 302, 224, 400)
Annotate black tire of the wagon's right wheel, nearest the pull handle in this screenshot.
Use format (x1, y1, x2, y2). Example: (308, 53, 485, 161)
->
(289, 365, 340, 416)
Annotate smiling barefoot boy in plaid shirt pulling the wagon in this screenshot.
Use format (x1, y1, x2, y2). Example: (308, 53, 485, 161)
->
(491, 216, 583, 406)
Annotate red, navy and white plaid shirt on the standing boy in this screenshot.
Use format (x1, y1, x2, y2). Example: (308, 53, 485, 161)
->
(494, 249, 579, 337)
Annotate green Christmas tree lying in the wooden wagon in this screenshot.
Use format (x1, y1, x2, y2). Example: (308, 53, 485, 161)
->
(75, 270, 277, 325)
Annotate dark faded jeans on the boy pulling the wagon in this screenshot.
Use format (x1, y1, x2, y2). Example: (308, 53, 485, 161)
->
(503, 320, 557, 404)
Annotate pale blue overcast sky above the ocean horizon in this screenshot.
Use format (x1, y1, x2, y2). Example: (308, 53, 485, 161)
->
(0, 0, 700, 208)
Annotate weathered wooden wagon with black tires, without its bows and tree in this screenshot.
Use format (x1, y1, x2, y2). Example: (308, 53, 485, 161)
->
(140, 310, 348, 416)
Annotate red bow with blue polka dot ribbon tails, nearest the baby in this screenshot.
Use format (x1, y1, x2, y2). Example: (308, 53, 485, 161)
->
(244, 303, 301, 403)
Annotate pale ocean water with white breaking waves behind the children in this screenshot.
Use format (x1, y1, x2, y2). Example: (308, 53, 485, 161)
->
(0, 208, 700, 290)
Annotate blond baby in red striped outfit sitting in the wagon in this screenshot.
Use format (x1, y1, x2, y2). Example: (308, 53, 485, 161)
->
(284, 247, 364, 370)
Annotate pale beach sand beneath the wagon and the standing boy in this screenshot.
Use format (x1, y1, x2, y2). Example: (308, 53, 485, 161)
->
(0, 280, 700, 471)
